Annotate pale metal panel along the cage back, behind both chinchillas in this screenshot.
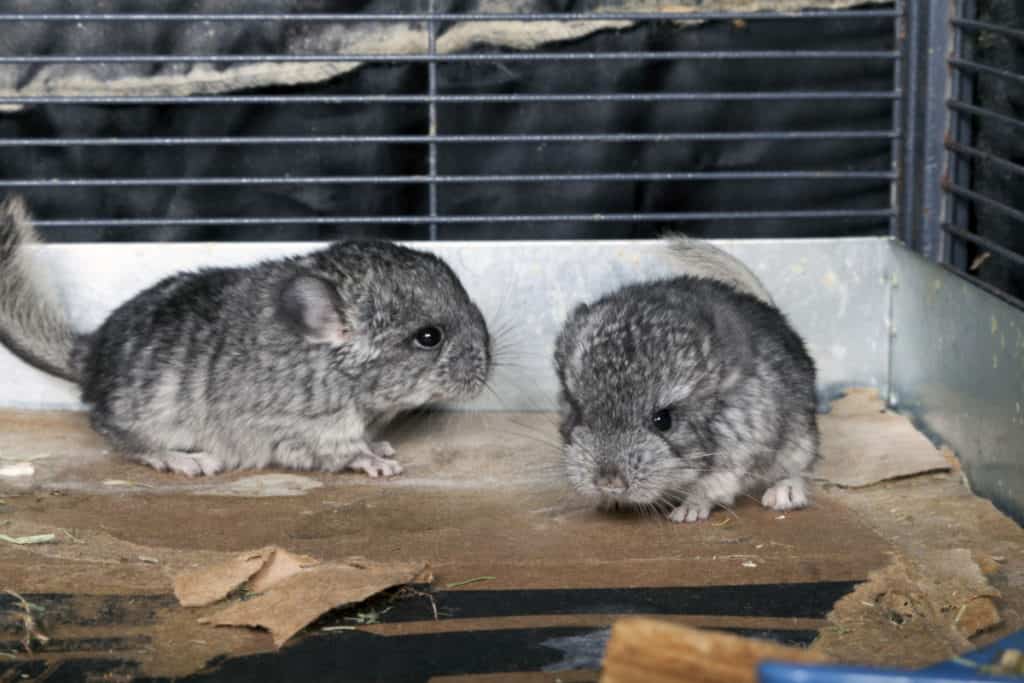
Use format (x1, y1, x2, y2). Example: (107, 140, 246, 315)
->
(0, 238, 889, 411)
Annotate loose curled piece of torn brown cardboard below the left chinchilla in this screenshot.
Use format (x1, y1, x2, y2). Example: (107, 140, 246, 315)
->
(174, 547, 431, 648)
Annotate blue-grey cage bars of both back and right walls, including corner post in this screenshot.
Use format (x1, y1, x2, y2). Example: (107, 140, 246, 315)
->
(0, 0, 1024, 303)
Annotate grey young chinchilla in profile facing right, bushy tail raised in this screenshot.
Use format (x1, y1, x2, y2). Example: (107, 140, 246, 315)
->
(0, 198, 492, 477)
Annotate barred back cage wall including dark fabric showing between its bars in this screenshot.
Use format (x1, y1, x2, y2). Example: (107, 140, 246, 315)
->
(0, 0, 903, 242)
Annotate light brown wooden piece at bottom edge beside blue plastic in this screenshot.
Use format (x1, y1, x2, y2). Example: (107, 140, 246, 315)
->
(601, 616, 826, 683)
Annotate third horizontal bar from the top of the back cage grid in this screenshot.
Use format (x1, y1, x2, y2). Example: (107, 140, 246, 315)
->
(0, 90, 901, 104)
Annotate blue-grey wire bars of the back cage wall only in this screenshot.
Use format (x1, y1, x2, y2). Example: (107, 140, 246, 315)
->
(0, 0, 905, 240)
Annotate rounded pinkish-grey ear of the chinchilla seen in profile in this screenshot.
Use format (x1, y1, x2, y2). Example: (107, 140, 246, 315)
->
(278, 274, 351, 346)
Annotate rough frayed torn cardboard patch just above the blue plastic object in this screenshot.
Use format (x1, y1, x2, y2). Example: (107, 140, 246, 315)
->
(813, 549, 1001, 668)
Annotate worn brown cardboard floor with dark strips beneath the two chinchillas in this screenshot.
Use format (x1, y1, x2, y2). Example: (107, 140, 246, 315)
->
(0, 392, 1024, 681)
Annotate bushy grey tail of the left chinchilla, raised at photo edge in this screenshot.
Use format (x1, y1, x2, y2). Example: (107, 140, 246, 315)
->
(0, 197, 78, 382)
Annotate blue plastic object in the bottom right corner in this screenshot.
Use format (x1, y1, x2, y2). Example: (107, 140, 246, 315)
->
(758, 631, 1024, 683)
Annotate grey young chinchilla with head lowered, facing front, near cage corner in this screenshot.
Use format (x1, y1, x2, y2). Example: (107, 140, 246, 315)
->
(555, 238, 818, 522)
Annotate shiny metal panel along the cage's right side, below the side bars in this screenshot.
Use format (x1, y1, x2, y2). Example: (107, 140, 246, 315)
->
(891, 245, 1024, 521)
